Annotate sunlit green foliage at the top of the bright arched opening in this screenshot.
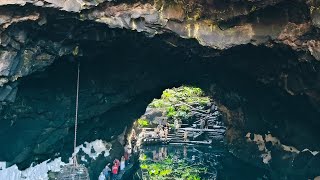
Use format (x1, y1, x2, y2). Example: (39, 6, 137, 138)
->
(149, 86, 211, 121)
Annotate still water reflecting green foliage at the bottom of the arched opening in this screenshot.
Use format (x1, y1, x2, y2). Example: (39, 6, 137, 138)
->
(139, 144, 268, 180)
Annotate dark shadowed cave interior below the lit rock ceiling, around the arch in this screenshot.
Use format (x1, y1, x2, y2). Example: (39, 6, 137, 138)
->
(0, 10, 320, 178)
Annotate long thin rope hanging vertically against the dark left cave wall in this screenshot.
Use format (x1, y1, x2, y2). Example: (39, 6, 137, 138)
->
(73, 63, 80, 166)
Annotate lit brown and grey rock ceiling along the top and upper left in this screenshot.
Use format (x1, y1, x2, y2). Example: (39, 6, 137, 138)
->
(0, 0, 320, 106)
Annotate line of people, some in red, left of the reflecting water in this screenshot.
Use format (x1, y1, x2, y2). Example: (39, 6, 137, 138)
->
(99, 145, 132, 180)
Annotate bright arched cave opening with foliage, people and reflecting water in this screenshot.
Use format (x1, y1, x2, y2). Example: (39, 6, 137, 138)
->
(128, 86, 264, 180)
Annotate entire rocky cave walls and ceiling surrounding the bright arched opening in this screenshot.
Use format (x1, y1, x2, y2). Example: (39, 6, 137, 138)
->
(0, 0, 320, 179)
